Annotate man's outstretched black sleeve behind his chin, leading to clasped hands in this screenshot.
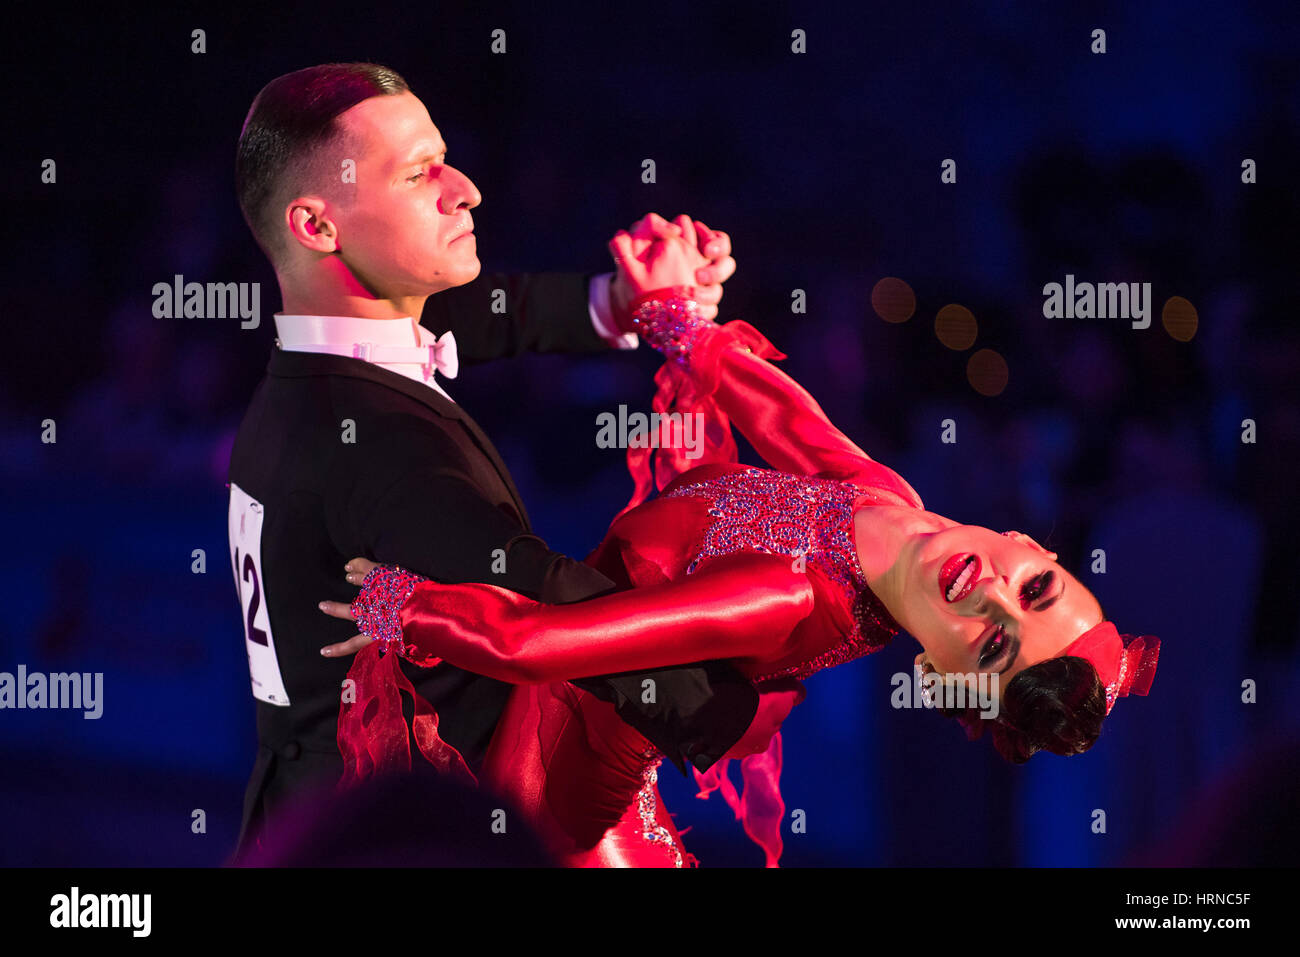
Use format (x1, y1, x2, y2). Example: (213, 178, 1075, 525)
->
(420, 273, 610, 364)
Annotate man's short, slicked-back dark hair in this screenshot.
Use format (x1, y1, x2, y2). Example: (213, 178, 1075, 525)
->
(235, 64, 410, 264)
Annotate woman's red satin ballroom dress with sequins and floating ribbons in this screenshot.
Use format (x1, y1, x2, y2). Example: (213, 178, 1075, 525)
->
(339, 299, 923, 867)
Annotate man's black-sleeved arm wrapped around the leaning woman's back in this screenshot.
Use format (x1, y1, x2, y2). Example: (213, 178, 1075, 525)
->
(347, 416, 758, 774)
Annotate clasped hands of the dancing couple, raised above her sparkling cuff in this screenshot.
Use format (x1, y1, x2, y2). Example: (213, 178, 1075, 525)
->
(610, 213, 736, 332)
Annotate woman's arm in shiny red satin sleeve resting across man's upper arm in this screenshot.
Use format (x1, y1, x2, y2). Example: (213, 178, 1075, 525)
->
(322, 555, 814, 684)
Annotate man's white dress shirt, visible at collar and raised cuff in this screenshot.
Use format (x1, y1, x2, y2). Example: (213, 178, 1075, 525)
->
(276, 273, 640, 402)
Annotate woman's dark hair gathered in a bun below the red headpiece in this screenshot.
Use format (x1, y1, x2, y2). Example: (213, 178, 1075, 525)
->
(937, 655, 1106, 765)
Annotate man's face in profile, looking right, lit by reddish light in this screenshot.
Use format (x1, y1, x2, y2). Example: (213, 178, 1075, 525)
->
(329, 92, 482, 299)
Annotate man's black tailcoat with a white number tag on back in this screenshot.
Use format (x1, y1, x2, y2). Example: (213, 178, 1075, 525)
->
(230, 273, 758, 850)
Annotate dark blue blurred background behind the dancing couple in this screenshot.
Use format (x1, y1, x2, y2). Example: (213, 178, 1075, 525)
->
(0, 3, 1300, 866)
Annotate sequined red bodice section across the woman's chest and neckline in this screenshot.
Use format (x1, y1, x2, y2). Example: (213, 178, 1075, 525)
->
(664, 468, 900, 681)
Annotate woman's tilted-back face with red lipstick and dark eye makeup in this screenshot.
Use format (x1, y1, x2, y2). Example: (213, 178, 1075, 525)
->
(898, 525, 1102, 692)
